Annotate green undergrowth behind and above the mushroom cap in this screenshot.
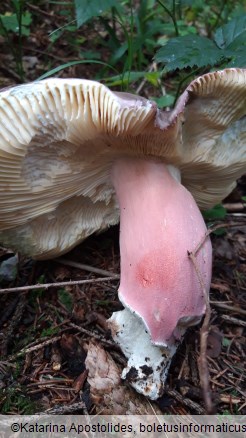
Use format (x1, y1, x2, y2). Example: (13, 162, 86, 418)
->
(0, 0, 246, 107)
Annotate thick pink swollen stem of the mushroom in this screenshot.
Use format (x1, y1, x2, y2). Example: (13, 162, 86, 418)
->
(108, 158, 212, 398)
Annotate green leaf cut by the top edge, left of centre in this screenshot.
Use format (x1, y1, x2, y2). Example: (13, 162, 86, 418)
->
(75, 0, 120, 28)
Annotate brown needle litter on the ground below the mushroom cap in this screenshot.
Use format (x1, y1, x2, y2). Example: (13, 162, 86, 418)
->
(0, 202, 246, 415)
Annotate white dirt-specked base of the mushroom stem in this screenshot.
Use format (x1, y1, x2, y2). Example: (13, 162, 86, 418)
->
(108, 309, 180, 400)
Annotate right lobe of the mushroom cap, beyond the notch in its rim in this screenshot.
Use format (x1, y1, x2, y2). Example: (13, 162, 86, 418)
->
(177, 69, 246, 209)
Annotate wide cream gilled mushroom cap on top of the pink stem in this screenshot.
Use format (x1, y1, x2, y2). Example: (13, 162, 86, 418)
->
(0, 69, 246, 258)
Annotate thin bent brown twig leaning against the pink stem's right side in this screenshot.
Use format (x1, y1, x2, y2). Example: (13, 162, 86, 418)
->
(188, 230, 214, 414)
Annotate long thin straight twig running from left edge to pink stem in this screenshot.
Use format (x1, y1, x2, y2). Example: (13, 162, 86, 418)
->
(0, 276, 119, 294)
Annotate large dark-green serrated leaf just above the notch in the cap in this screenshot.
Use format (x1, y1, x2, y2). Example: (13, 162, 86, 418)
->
(155, 35, 224, 71)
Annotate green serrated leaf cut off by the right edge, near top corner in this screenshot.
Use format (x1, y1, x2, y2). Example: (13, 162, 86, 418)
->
(214, 15, 246, 49)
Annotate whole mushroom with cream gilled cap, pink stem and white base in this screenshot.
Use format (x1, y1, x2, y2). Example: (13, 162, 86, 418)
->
(0, 69, 246, 399)
